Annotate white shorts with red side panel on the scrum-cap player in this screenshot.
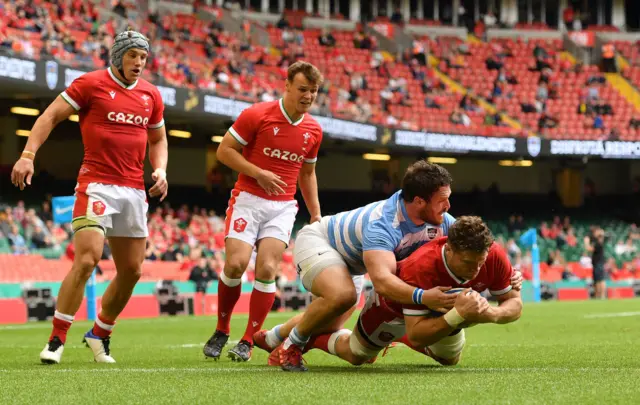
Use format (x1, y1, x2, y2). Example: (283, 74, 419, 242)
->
(72, 183, 149, 238)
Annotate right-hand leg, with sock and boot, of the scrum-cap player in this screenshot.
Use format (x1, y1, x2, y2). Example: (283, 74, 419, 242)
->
(84, 237, 147, 363)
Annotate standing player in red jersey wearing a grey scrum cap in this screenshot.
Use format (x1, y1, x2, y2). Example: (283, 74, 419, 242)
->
(11, 31, 168, 364)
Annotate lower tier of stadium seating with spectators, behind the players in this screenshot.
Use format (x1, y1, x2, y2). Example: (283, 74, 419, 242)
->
(0, 196, 640, 283)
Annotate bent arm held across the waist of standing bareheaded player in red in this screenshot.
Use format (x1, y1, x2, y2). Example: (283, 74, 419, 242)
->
(216, 131, 287, 195)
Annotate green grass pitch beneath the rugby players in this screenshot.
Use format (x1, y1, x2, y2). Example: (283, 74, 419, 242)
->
(0, 300, 640, 405)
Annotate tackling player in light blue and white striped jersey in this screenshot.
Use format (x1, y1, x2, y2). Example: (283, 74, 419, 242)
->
(254, 160, 457, 371)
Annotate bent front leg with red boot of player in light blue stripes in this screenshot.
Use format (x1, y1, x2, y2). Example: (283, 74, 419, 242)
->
(280, 265, 357, 371)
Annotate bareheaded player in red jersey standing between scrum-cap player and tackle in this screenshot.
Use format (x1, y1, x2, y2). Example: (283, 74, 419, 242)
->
(203, 61, 322, 361)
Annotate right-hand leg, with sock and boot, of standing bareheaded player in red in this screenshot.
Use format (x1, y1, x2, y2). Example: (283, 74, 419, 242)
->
(229, 238, 287, 361)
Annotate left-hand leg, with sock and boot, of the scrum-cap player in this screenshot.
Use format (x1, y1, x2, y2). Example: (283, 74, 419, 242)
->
(40, 224, 104, 364)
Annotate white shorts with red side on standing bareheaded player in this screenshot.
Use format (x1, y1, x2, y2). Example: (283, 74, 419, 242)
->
(225, 189, 298, 246)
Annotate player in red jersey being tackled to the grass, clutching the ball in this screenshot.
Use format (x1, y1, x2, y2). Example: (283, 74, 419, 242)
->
(314, 216, 522, 365)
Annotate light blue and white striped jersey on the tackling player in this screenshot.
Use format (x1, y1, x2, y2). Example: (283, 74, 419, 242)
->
(322, 191, 455, 274)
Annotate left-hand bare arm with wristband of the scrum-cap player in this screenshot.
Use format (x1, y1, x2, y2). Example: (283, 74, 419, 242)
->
(11, 96, 75, 190)
